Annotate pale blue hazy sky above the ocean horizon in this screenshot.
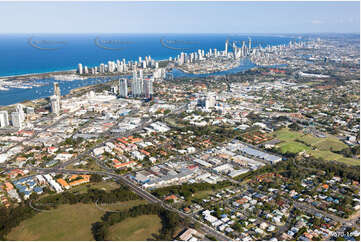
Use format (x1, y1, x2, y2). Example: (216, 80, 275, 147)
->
(0, 2, 360, 33)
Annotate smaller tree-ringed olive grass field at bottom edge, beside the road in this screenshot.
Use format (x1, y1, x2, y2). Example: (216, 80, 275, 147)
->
(106, 215, 162, 241)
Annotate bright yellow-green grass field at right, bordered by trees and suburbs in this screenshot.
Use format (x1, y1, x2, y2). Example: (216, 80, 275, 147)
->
(273, 128, 360, 165)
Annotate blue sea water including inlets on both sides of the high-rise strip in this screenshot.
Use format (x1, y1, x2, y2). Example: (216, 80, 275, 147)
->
(0, 34, 295, 105)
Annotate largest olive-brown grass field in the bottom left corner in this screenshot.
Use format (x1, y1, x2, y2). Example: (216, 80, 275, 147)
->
(7, 204, 104, 240)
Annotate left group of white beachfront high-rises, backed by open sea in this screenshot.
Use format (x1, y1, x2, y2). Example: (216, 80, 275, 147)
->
(77, 56, 159, 75)
